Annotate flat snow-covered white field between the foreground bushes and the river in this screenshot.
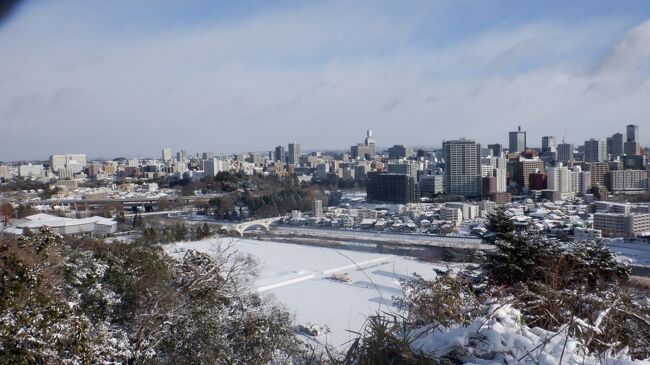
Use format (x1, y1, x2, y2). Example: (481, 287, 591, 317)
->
(165, 239, 445, 347)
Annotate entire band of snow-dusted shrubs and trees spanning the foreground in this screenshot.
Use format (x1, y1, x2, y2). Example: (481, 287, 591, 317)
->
(0, 206, 650, 365)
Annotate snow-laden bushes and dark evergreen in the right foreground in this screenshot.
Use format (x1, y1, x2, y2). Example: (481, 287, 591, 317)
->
(334, 206, 650, 364)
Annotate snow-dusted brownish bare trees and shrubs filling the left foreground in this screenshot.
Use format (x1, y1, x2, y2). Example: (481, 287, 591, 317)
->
(0, 229, 298, 364)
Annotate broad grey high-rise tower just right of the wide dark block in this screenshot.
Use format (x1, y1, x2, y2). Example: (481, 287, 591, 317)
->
(442, 138, 481, 196)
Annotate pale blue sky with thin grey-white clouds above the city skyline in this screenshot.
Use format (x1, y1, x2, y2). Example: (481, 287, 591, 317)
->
(0, 0, 650, 161)
